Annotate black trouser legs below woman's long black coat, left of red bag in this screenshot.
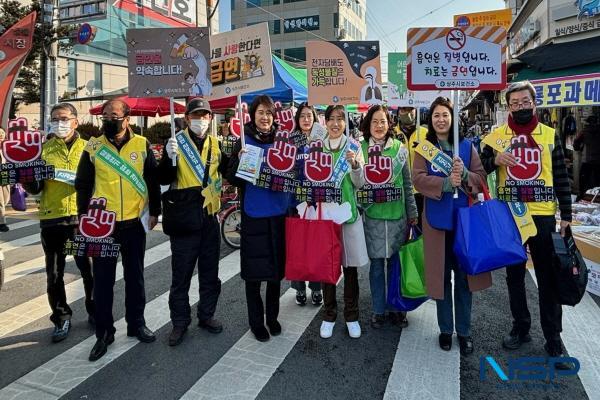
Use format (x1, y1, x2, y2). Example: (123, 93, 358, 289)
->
(246, 281, 281, 329)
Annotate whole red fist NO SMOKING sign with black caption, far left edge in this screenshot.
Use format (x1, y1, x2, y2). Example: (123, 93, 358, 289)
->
(0, 118, 55, 186)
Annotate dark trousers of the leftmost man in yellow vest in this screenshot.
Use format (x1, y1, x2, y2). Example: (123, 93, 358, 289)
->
(41, 225, 94, 324)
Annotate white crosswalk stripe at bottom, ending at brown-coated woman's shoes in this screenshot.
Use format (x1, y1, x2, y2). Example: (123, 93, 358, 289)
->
(383, 300, 460, 400)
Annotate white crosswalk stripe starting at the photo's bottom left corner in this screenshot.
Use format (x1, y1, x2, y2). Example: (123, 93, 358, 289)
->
(0, 251, 239, 400)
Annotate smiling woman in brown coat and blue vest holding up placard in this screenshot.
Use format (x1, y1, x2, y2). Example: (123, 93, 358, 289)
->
(413, 97, 491, 355)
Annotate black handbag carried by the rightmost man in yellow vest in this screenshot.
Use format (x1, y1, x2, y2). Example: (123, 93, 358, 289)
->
(552, 227, 588, 306)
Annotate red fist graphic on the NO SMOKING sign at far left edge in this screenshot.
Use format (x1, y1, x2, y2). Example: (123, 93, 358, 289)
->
(2, 118, 42, 163)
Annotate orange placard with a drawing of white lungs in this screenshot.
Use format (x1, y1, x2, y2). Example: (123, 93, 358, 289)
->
(306, 41, 383, 105)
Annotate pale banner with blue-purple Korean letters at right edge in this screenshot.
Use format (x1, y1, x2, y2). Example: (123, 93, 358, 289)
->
(531, 73, 600, 108)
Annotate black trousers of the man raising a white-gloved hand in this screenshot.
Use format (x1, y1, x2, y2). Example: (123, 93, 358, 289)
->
(169, 215, 221, 327)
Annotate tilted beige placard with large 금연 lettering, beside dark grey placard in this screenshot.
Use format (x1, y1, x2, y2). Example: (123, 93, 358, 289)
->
(210, 22, 275, 99)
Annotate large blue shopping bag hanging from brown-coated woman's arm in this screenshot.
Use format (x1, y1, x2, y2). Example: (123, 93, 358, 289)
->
(454, 195, 528, 275)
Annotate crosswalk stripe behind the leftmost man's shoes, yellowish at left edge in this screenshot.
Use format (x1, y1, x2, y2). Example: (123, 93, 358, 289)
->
(0, 242, 171, 338)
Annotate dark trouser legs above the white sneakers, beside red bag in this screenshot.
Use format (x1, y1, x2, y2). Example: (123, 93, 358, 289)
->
(323, 267, 358, 322)
